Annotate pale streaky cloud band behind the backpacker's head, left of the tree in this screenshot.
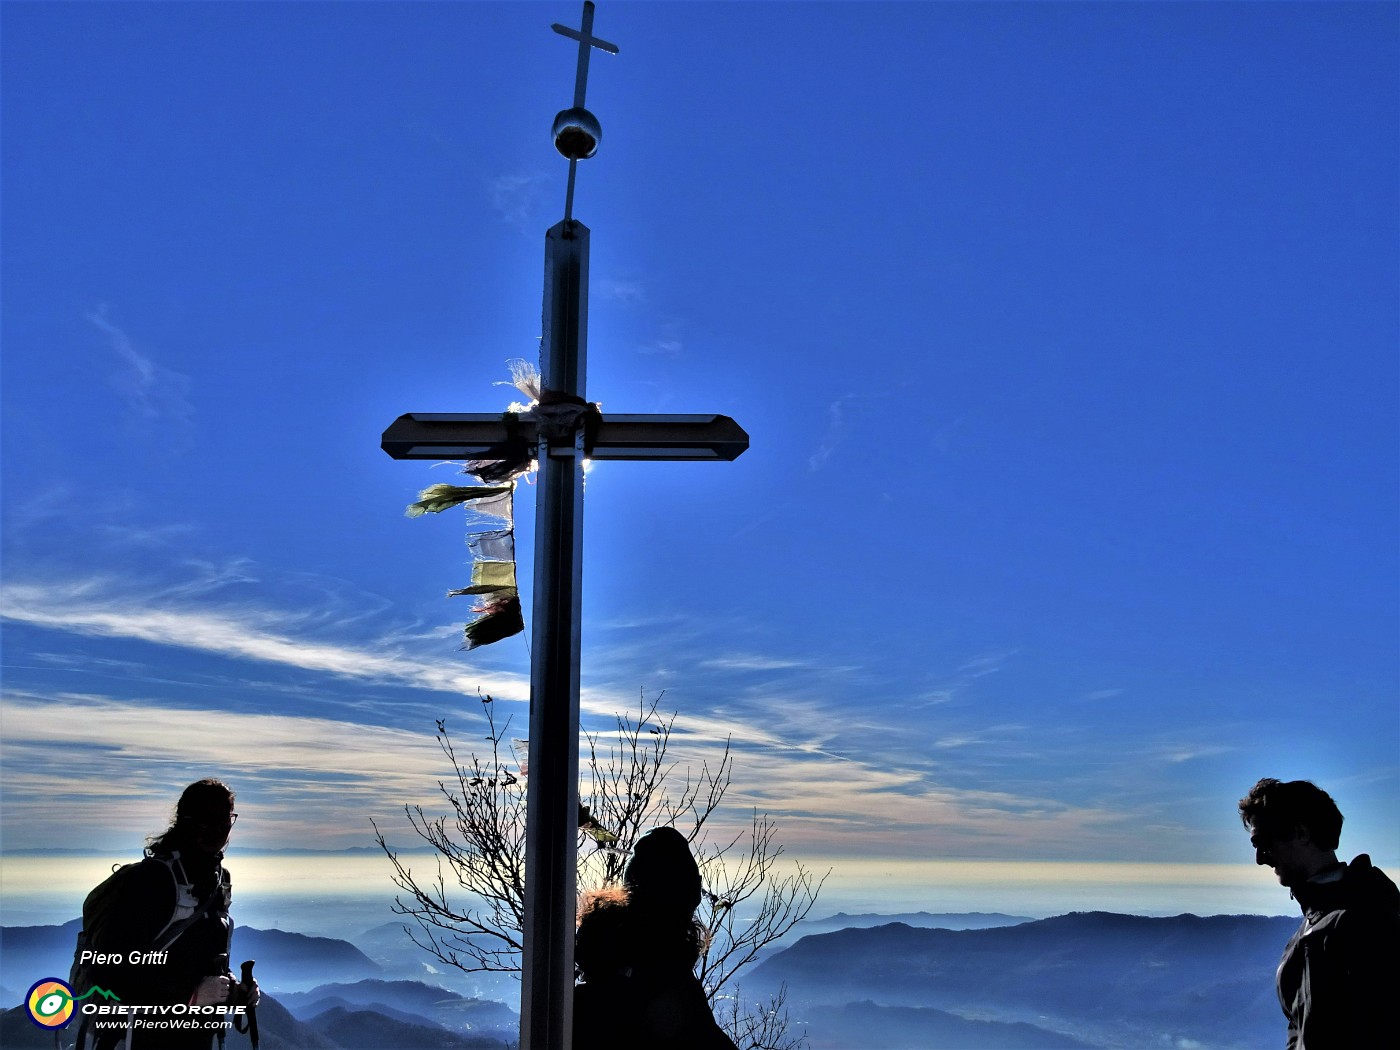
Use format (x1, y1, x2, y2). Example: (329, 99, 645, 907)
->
(0, 693, 448, 848)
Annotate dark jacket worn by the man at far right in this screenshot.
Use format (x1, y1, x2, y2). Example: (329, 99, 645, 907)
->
(1278, 854, 1400, 1050)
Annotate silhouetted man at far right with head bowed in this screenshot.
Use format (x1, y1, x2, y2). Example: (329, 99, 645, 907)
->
(1239, 778, 1400, 1050)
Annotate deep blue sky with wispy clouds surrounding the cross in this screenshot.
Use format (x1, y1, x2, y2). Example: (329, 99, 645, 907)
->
(0, 0, 1400, 896)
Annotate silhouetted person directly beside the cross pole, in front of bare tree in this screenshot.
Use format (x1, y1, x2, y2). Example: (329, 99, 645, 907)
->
(574, 827, 735, 1050)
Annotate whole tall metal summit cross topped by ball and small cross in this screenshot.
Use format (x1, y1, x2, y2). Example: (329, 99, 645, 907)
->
(381, 3, 749, 1050)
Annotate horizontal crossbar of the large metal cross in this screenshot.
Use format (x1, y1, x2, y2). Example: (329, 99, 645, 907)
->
(381, 412, 749, 462)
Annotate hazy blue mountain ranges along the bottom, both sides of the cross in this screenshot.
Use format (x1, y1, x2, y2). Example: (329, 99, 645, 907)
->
(0, 911, 1296, 1050)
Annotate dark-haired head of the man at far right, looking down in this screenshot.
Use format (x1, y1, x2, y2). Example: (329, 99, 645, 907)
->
(1239, 777, 1343, 886)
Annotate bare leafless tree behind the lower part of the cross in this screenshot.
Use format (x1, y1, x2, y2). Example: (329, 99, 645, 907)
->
(375, 693, 826, 1050)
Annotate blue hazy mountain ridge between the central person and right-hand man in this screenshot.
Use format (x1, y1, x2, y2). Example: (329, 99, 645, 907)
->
(750, 911, 1296, 1049)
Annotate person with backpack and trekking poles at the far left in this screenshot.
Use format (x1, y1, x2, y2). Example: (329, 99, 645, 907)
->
(71, 778, 259, 1050)
